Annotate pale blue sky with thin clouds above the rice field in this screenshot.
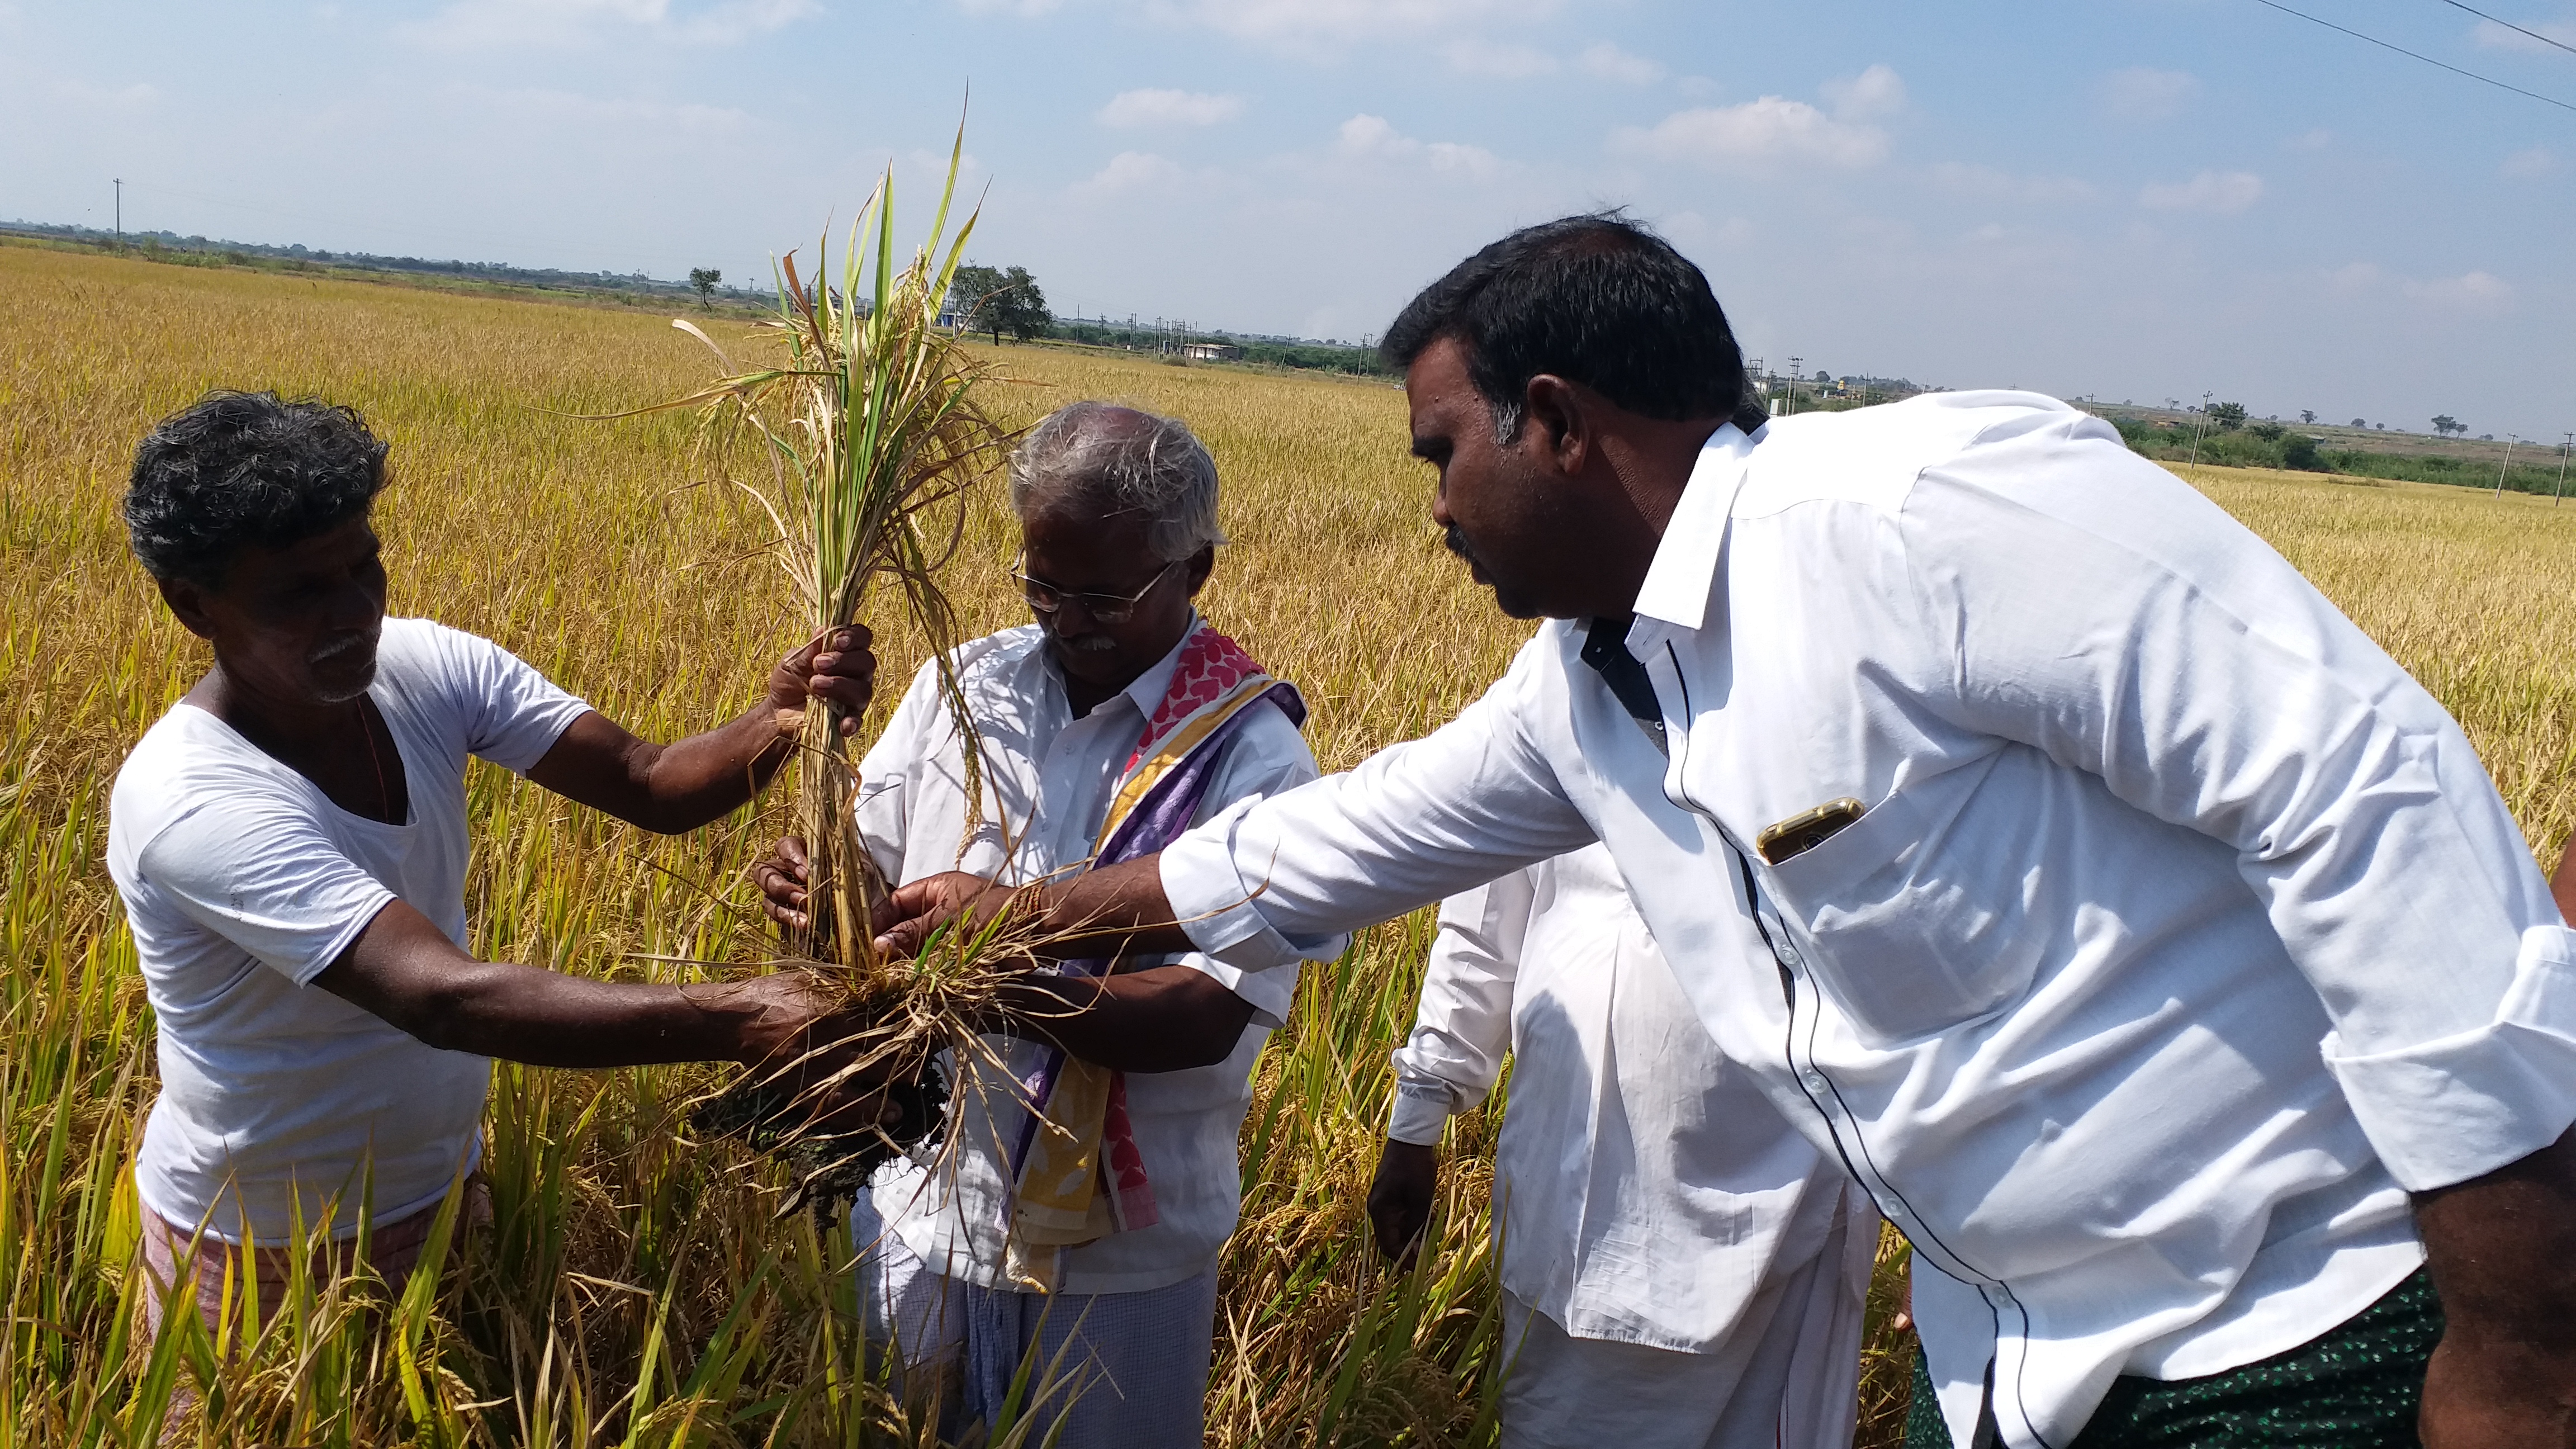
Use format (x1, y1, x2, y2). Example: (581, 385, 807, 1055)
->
(0, 0, 2576, 443)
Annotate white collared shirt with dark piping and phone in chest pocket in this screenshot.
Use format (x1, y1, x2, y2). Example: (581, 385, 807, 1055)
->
(1162, 392, 2576, 1446)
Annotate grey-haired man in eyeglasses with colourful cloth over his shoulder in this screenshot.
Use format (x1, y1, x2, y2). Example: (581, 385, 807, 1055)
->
(755, 402, 1339, 1449)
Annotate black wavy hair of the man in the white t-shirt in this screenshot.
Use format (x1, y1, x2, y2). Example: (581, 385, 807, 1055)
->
(126, 392, 386, 588)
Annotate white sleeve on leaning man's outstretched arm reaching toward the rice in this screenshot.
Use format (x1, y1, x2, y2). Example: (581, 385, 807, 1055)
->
(1159, 634, 1592, 969)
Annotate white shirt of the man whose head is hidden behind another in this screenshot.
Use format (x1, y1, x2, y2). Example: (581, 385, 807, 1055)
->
(1386, 840, 1876, 1353)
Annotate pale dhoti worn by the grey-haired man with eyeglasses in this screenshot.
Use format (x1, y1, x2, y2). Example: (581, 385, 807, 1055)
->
(850, 1194, 1216, 1449)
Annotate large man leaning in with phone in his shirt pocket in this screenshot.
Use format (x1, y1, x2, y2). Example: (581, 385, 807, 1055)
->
(884, 216, 2576, 1449)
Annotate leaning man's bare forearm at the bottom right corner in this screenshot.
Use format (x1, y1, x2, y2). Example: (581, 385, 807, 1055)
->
(2414, 1124, 2576, 1449)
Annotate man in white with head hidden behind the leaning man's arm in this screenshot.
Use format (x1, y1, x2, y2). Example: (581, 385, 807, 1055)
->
(1368, 840, 1878, 1449)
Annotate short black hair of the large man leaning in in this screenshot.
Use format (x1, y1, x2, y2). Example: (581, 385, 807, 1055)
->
(1378, 211, 1762, 433)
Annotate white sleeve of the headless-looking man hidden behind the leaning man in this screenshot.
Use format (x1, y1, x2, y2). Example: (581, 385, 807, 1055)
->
(1386, 869, 1535, 1145)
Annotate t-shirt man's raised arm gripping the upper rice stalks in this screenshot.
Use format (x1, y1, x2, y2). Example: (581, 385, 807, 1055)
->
(528, 624, 876, 835)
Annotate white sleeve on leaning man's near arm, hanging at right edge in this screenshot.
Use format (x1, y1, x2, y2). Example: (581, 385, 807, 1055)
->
(1901, 423, 2576, 1191)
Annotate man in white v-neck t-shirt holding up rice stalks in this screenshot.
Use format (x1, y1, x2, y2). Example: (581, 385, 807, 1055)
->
(108, 392, 876, 1323)
